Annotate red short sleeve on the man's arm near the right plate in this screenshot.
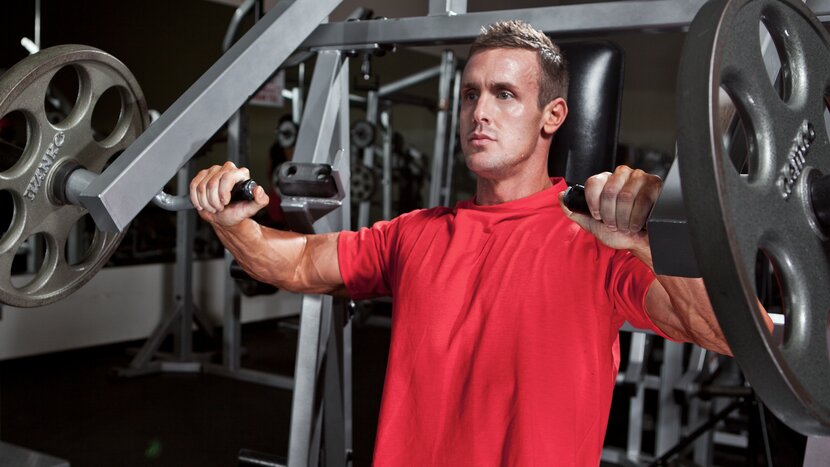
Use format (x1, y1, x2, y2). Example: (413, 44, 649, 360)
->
(606, 250, 668, 337)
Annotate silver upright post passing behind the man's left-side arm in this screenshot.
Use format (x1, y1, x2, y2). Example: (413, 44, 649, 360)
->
(282, 50, 352, 467)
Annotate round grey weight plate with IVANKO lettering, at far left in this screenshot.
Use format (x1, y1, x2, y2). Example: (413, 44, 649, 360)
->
(0, 45, 148, 307)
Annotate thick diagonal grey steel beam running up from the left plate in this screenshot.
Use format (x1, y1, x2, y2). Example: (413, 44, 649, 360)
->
(80, 0, 340, 231)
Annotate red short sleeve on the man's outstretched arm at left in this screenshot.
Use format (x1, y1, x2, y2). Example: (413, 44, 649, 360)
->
(337, 219, 398, 300)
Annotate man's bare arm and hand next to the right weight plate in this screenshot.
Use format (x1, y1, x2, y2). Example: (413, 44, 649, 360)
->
(560, 166, 732, 355)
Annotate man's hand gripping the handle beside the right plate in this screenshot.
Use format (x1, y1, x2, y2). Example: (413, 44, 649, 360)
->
(559, 165, 663, 251)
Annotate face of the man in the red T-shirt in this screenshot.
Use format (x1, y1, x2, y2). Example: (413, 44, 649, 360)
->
(459, 49, 547, 178)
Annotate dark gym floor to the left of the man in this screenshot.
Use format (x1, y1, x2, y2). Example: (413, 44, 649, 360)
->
(0, 314, 389, 467)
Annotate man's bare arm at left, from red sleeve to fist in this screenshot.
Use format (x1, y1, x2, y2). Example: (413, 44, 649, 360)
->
(190, 162, 348, 296)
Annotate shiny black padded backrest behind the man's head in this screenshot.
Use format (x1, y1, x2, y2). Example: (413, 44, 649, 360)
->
(548, 42, 624, 183)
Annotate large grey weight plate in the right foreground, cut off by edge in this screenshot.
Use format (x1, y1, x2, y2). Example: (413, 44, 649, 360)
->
(678, 0, 830, 435)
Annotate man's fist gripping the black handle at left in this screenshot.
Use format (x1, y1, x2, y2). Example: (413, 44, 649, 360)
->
(190, 162, 268, 227)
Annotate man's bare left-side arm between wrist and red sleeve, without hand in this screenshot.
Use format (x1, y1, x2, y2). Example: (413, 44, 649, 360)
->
(214, 219, 345, 294)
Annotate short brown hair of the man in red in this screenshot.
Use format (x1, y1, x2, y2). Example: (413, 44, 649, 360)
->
(470, 20, 568, 109)
